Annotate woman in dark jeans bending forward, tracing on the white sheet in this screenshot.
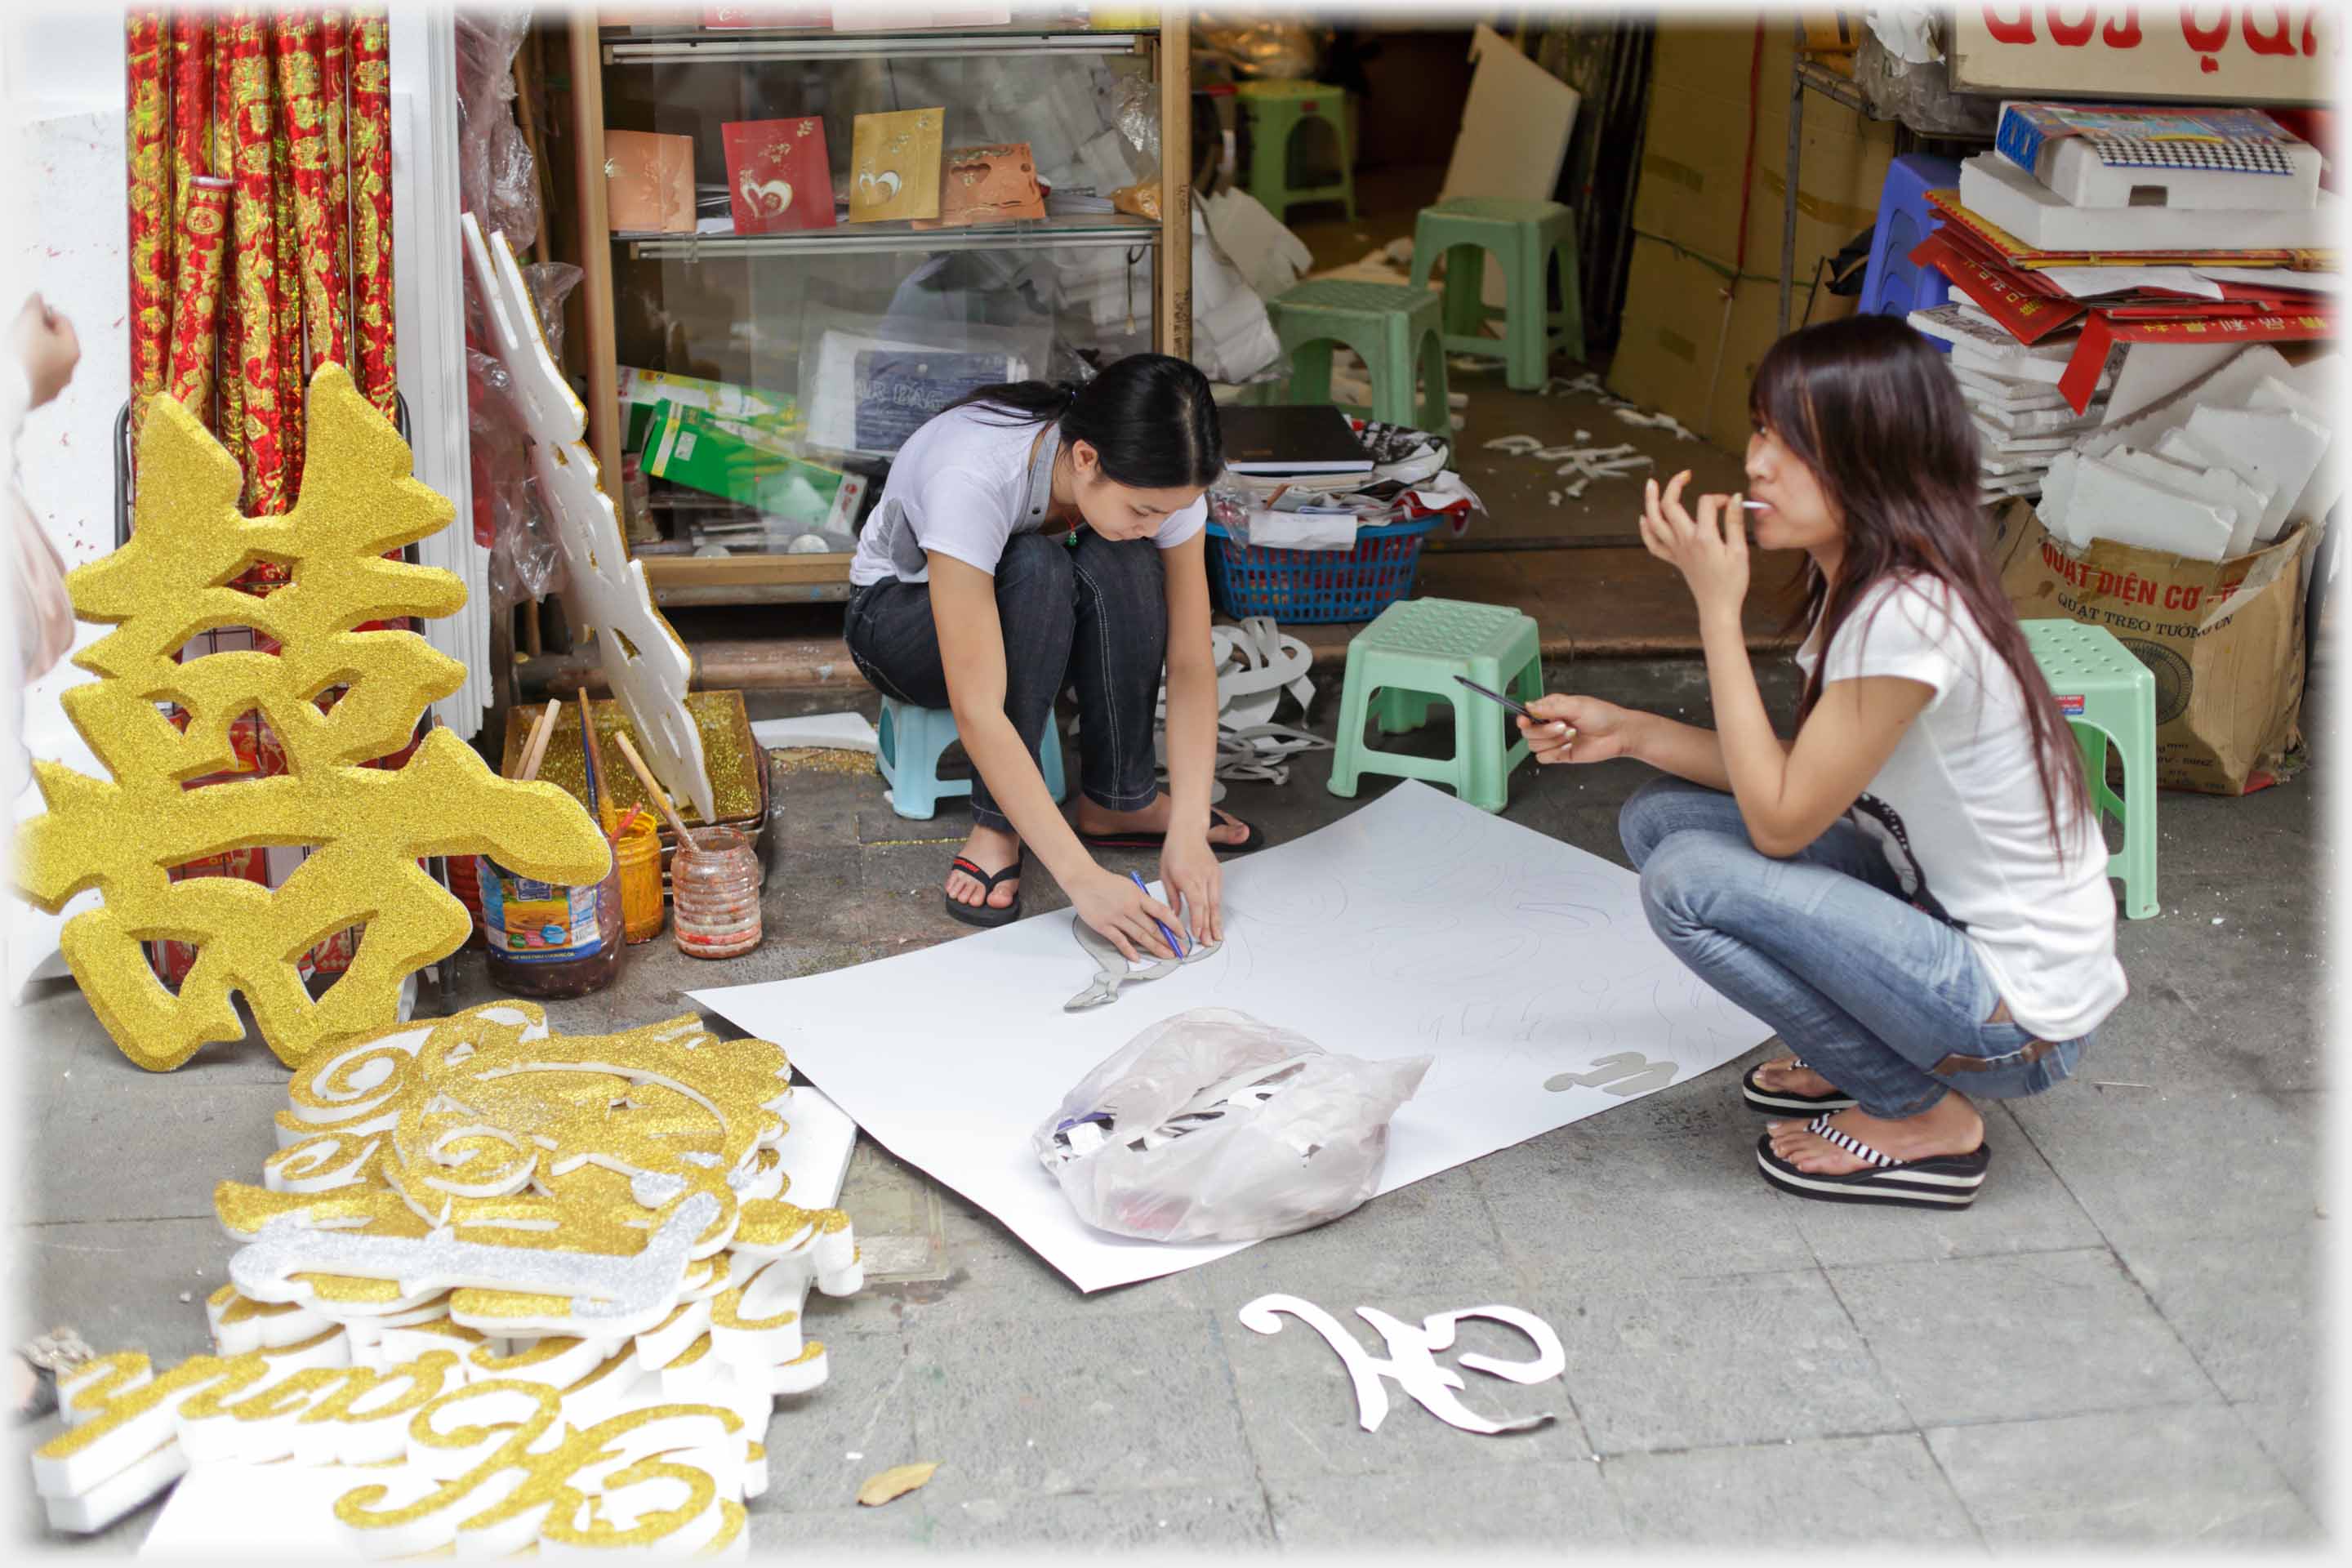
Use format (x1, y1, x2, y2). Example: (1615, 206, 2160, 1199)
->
(847, 355, 1261, 959)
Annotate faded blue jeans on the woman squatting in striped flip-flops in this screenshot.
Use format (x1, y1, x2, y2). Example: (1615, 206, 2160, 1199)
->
(1618, 778, 2091, 1119)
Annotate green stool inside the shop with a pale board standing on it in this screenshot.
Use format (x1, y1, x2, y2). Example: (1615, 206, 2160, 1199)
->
(1414, 198, 1585, 393)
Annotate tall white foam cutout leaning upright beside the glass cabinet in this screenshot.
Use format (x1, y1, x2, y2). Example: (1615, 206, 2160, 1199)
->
(459, 212, 717, 822)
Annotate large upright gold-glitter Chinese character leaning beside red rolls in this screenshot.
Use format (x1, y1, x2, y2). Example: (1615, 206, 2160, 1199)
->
(16, 364, 612, 1072)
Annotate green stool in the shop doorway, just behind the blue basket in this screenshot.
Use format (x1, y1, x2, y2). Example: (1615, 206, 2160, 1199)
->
(1265, 278, 1454, 435)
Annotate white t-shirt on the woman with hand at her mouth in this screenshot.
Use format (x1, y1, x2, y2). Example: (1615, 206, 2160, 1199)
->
(1797, 578, 2127, 1039)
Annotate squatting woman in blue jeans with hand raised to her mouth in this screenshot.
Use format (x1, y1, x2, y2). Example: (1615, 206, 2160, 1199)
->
(1519, 315, 2124, 1209)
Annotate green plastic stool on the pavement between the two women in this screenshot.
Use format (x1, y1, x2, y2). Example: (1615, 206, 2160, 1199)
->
(1331, 599, 1543, 811)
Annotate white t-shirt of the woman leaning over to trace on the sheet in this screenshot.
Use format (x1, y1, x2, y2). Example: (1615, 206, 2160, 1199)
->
(849, 404, 1209, 588)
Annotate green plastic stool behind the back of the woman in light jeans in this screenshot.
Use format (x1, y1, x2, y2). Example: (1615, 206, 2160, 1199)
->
(2023, 621, 2157, 920)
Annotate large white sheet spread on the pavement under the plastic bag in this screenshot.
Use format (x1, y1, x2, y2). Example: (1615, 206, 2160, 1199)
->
(692, 778, 1771, 1290)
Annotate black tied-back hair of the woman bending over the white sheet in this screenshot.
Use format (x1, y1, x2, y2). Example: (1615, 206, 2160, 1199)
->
(941, 355, 1225, 489)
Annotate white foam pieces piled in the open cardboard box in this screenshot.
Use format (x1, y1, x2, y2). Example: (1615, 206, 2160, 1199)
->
(2037, 348, 2342, 562)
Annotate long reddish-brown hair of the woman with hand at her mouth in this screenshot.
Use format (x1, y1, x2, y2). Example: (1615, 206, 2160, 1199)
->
(1748, 315, 2088, 861)
